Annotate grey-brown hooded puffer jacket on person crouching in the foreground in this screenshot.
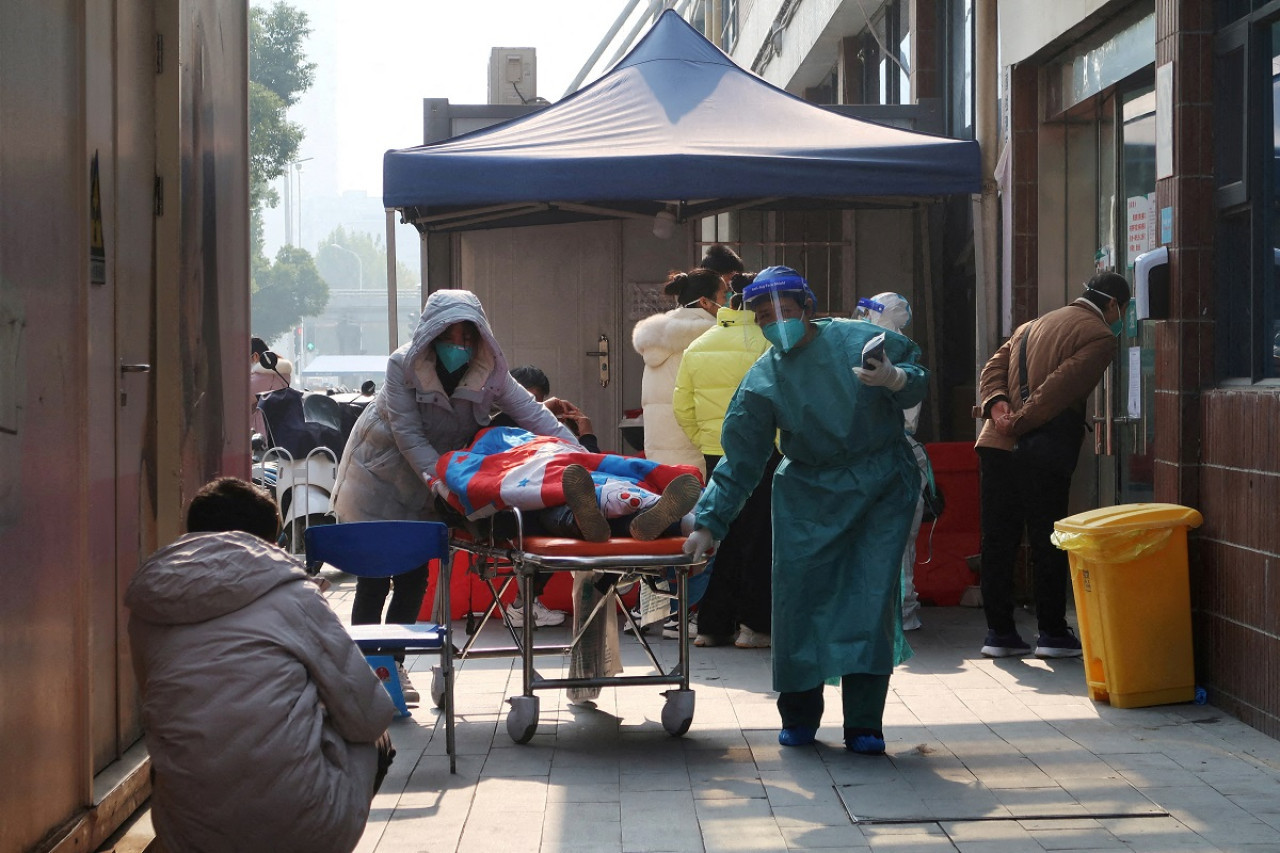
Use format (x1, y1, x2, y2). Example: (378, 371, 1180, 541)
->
(124, 532, 396, 853)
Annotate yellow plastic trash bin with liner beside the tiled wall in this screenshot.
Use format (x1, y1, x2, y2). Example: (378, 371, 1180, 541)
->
(1052, 503, 1203, 708)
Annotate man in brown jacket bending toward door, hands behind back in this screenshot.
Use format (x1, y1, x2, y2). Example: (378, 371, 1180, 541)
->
(974, 273, 1129, 657)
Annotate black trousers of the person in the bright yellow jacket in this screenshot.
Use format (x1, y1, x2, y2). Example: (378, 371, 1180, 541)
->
(698, 452, 782, 637)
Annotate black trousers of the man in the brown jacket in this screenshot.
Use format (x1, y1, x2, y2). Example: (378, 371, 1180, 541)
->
(978, 447, 1071, 635)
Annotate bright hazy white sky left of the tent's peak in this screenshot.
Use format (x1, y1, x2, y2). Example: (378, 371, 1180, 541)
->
(277, 0, 648, 196)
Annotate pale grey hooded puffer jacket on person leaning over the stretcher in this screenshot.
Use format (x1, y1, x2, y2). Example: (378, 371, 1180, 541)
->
(333, 291, 577, 521)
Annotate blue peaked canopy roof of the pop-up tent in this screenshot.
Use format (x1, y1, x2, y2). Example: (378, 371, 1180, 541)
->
(383, 10, 980, 228)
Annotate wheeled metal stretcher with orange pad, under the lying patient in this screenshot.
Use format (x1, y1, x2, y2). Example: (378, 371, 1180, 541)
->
(431, 510, 707, 743)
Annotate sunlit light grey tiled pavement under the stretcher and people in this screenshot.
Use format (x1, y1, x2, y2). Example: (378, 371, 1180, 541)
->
(322, 576, 1280, 853)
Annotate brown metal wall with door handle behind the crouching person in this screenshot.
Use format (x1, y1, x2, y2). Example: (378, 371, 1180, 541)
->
(0, 0, 248, 850)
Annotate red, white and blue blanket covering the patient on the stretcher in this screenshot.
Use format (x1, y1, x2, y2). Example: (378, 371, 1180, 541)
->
(430, 427, 700, 520)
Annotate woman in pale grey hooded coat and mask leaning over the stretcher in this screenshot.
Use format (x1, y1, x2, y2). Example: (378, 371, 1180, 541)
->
(333, 291, 577, 702)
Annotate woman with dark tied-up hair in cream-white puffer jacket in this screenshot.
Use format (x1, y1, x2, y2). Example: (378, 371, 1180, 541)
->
(631, 268, 728, 478)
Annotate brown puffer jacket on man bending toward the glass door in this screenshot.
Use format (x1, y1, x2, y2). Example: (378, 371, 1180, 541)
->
(973, 298, 1116, 450)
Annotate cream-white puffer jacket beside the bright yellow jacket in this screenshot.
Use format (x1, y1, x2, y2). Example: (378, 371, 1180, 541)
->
(631, 307, 716, 475)
